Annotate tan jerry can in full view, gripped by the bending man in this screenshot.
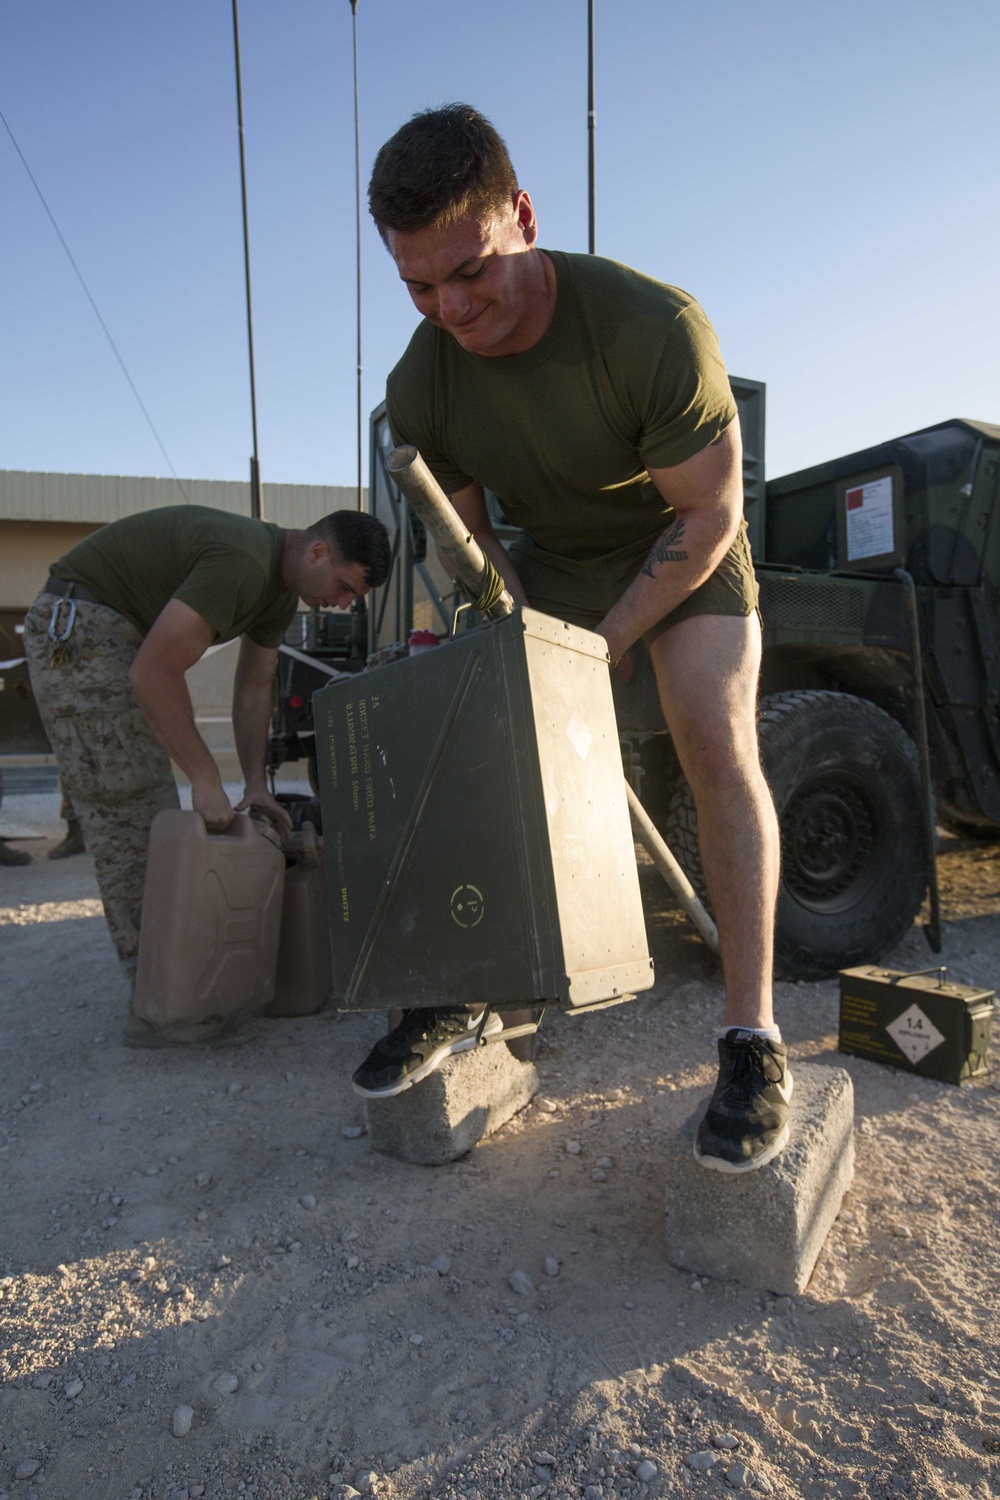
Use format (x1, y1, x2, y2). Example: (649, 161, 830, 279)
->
(132, 809, 285, 1026)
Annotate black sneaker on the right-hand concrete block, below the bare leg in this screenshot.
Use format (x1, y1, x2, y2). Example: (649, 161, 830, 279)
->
(694, 1028, 792, 1172)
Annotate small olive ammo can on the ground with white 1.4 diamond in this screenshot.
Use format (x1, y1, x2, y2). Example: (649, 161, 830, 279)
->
(840, 965, 994, 1083)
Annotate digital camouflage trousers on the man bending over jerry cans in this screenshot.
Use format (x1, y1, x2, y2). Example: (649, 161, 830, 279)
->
(24, 593, 178, 981)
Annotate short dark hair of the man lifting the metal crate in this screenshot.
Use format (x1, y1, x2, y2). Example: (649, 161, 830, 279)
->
(369, 104, 517, 239)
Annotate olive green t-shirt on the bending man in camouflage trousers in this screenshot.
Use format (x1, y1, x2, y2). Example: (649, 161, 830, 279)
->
(51, 506, 298, 647)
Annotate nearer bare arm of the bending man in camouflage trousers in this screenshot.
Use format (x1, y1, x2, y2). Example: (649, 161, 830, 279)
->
(129, 599, 232, 831)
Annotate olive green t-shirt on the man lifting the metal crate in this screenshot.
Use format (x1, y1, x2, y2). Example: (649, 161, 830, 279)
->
(385, 251, 736, 558)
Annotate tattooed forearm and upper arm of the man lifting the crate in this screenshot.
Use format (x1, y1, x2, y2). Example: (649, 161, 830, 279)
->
(597, 420, 744, 662)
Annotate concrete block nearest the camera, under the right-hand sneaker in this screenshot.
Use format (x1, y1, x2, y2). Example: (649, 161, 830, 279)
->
(666, 1062, 855, 1296)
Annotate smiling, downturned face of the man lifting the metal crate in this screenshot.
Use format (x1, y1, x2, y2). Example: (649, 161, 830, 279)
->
(387, 192, 544, 354)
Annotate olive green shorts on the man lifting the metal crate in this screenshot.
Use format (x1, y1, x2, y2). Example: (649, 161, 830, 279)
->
(510, 522, 757, 645)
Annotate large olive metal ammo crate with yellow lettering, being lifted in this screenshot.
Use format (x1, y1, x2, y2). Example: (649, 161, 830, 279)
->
(313, 609, 652, 1011)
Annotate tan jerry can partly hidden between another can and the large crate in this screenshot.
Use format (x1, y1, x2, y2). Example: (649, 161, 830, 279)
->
(267, 824, 333, 1016)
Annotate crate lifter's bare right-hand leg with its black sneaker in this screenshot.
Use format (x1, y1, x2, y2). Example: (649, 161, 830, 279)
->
(651, 615, 792, 1172)
